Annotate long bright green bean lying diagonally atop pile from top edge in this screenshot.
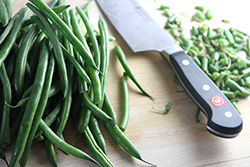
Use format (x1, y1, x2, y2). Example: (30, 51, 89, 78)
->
(30, 0, 97, 69)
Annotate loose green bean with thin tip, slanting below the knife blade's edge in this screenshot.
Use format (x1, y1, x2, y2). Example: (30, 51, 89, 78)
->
(115, 45, 154, 100)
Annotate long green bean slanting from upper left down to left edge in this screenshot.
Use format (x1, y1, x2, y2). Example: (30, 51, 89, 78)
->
(0, 8, 29, 66)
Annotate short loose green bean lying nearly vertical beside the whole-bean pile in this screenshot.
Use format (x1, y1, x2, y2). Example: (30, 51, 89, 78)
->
(119, 73, 129, 132)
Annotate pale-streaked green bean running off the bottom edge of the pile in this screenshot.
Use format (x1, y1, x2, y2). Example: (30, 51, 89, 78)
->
(83, 127, 114, 167)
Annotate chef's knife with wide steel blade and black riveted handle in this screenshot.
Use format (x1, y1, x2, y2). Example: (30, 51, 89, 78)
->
(96, 0, 243, 138)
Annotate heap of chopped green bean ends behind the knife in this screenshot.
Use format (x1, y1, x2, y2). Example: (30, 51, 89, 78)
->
(161, 6, 250, 112)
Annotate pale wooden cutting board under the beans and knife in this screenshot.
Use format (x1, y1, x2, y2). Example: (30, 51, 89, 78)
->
(0, 0, 250, 167)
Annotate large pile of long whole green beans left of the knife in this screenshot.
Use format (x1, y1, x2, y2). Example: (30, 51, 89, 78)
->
(0, 0, 156, 167)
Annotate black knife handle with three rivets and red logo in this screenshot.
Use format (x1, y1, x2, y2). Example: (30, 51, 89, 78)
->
(162, 51, 243, 138)
